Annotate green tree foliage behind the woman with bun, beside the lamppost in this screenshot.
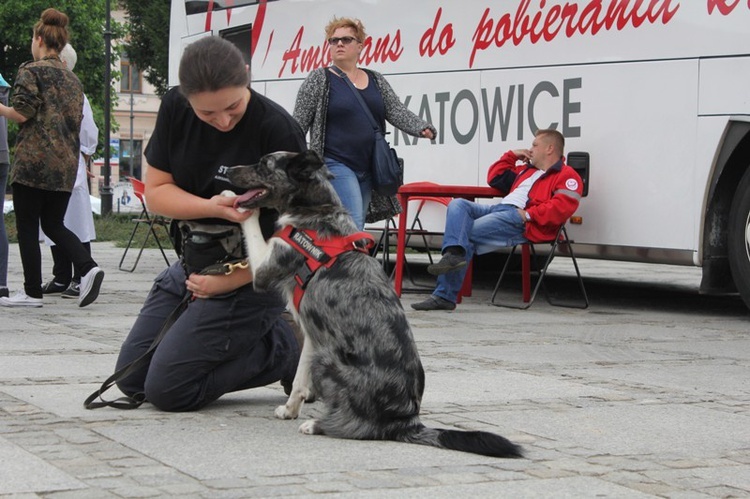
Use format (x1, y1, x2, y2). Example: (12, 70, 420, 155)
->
(0, 0, 125, 156)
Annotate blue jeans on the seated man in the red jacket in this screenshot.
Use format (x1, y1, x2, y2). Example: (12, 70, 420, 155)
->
(432, 199, 526, 303)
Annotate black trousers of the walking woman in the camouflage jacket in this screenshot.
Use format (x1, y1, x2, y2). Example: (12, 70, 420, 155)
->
(13, 183, 96, 298)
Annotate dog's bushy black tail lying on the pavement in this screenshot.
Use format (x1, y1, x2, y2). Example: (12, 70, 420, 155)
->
(397, 425, 523, 457)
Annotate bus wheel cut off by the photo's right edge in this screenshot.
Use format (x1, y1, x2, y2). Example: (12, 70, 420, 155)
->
(728, 169, 750, 307)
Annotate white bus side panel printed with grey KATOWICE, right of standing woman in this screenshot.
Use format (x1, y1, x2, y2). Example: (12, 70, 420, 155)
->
(389, 60, 704, 251)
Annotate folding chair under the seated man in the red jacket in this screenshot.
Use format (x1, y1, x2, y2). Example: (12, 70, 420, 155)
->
(490, 224, 589, 309)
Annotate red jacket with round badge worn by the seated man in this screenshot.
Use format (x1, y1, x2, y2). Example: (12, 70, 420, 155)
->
(487, 151, 583, 242)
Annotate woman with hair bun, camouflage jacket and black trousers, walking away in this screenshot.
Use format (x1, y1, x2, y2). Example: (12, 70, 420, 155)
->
(0, 8, 104, 307)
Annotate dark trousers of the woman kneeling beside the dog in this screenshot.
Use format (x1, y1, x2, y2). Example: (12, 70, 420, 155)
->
(116, 263, 300, 411)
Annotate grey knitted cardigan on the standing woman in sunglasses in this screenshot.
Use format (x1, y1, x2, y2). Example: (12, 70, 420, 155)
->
(294, 68, 437, 157)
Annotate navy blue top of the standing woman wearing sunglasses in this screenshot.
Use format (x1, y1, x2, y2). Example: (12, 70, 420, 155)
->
(324, 75, 385, 172)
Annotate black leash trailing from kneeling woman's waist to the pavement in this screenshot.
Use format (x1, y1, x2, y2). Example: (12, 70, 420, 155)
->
(83, 260, 248, 410)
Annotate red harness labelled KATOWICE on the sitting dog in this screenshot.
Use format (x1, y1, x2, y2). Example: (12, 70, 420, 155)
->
(274, 225, 375, 310)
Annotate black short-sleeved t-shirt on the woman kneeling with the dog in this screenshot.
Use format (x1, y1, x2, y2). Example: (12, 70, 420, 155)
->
(145, 87, 307, 237)
